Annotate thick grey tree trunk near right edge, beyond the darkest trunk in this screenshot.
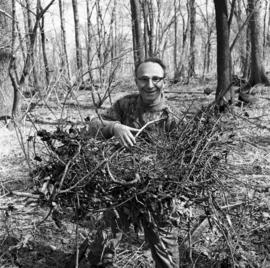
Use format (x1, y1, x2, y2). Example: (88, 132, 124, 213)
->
(248, 0, 270, 86)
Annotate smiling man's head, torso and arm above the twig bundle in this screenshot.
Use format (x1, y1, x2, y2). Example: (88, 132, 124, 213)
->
(90, 58, 177, 147)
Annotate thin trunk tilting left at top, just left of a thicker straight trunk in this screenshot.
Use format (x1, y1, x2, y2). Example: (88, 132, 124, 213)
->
(58, 0, 70, 79)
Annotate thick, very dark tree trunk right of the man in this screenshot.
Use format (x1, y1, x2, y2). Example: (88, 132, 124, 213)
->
(214, 0, 232, 106)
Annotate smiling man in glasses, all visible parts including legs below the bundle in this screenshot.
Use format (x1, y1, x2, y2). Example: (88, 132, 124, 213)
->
(89, 58, 179, 268)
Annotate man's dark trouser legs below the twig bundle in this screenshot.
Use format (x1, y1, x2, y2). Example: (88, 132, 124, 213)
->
(89, 210, 179, 268)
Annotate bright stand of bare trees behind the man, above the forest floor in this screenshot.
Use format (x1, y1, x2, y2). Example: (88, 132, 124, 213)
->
(1, 0, 270, 116)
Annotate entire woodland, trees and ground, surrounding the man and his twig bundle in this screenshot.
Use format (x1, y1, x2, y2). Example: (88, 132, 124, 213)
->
(0, 0, 270, 267)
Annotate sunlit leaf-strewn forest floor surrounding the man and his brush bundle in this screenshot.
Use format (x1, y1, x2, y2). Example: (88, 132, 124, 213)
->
(0, 78, 270, 268)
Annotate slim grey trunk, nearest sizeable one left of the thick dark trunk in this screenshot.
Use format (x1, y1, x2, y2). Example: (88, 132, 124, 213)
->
(188, 0, 196, 78)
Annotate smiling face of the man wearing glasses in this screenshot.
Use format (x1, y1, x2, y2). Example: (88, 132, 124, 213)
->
(136, 62, 164, 104)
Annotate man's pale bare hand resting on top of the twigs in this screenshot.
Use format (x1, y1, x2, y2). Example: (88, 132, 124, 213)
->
(113, 123, 140, 147)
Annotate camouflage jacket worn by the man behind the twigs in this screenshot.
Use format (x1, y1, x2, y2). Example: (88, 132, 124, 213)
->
(89, 93, 179, 137)
